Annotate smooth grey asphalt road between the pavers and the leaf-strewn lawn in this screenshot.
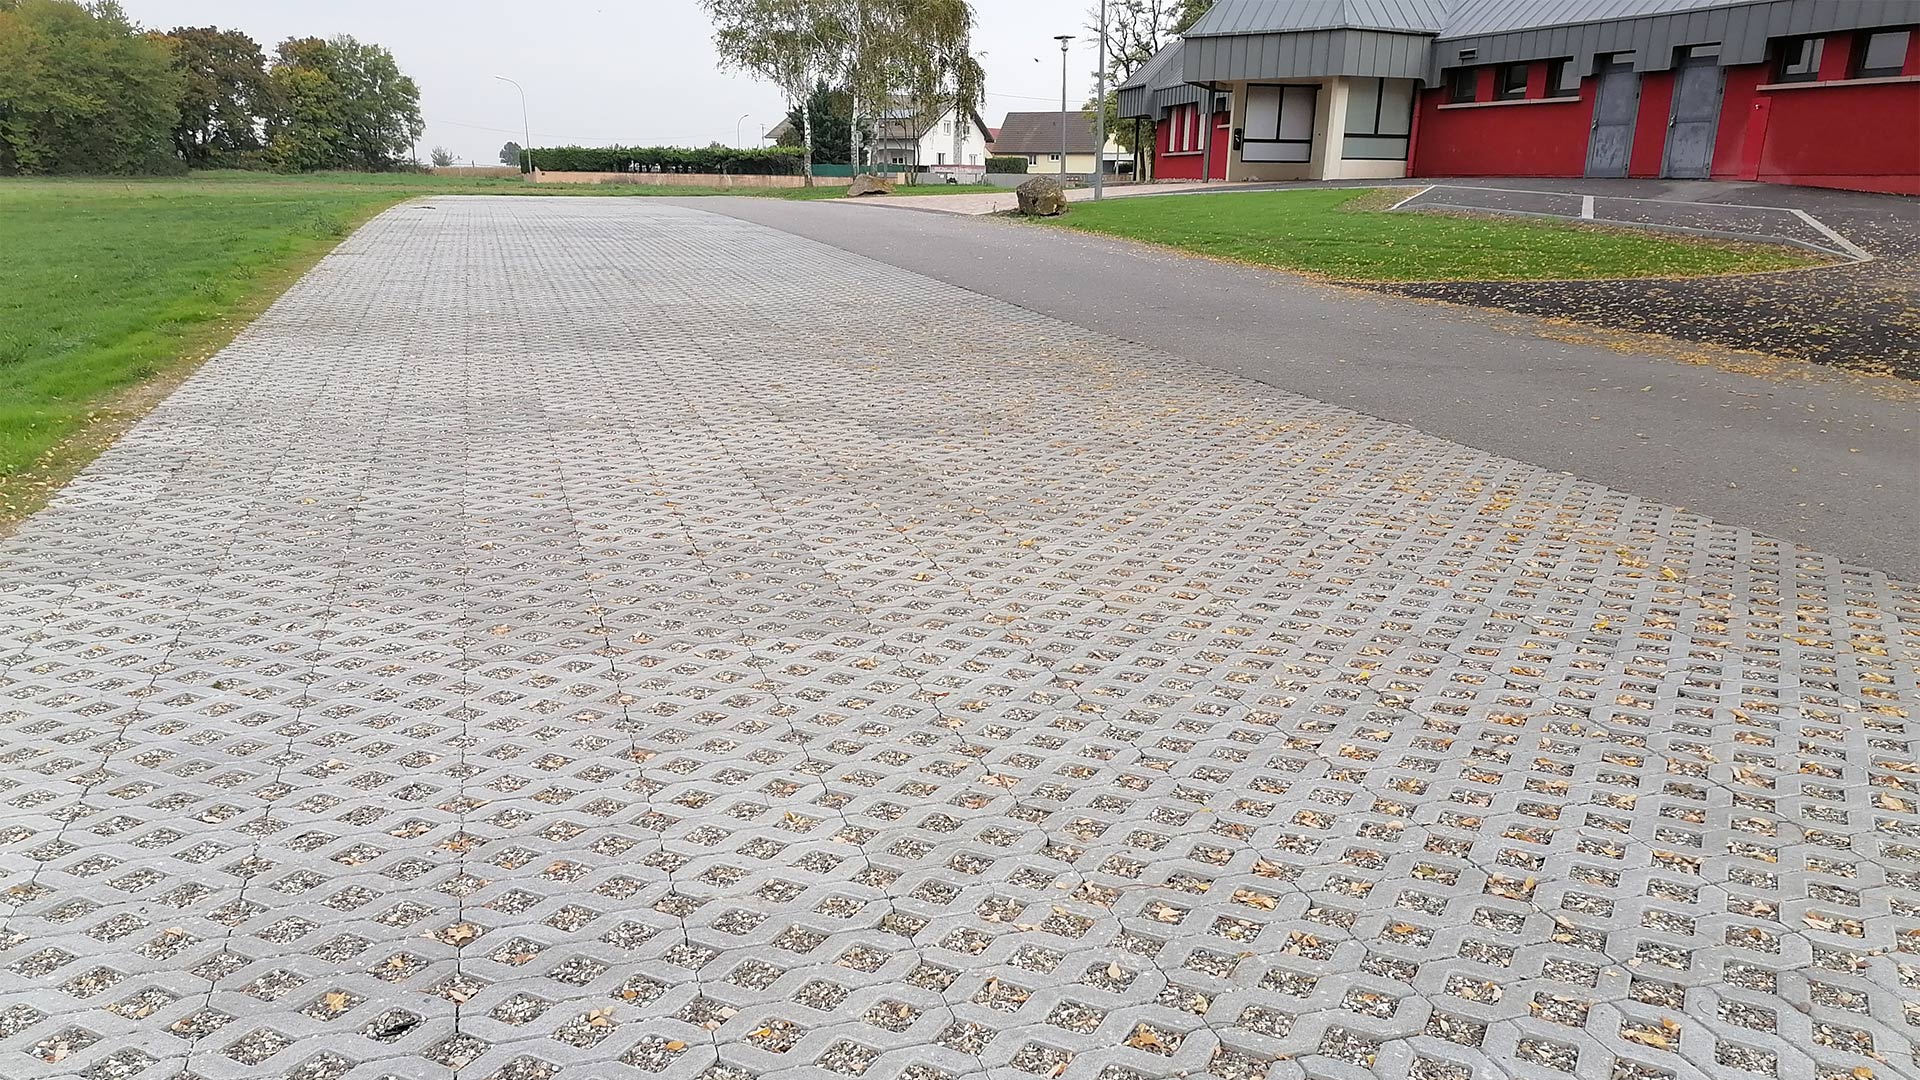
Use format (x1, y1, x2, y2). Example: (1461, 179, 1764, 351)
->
(684, 198, 1920, 580)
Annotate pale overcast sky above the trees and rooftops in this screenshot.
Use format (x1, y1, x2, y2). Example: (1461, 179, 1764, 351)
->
(123, 0, 1096, 161)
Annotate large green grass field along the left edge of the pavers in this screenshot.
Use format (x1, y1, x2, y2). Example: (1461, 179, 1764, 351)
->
(0, 173, 845, 525)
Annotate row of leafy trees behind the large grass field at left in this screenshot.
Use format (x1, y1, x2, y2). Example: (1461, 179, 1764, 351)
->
(0, 0, 426, 173)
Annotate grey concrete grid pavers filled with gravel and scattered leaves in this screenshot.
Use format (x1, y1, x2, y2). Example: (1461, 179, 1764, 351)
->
(0, 198, 1920, 1080)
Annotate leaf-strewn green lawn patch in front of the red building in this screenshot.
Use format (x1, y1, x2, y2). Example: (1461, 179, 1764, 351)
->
(1048, 188, 1820, 281)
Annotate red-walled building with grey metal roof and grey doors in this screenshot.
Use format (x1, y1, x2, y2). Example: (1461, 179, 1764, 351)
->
(1121, 0, 1920, 194)
